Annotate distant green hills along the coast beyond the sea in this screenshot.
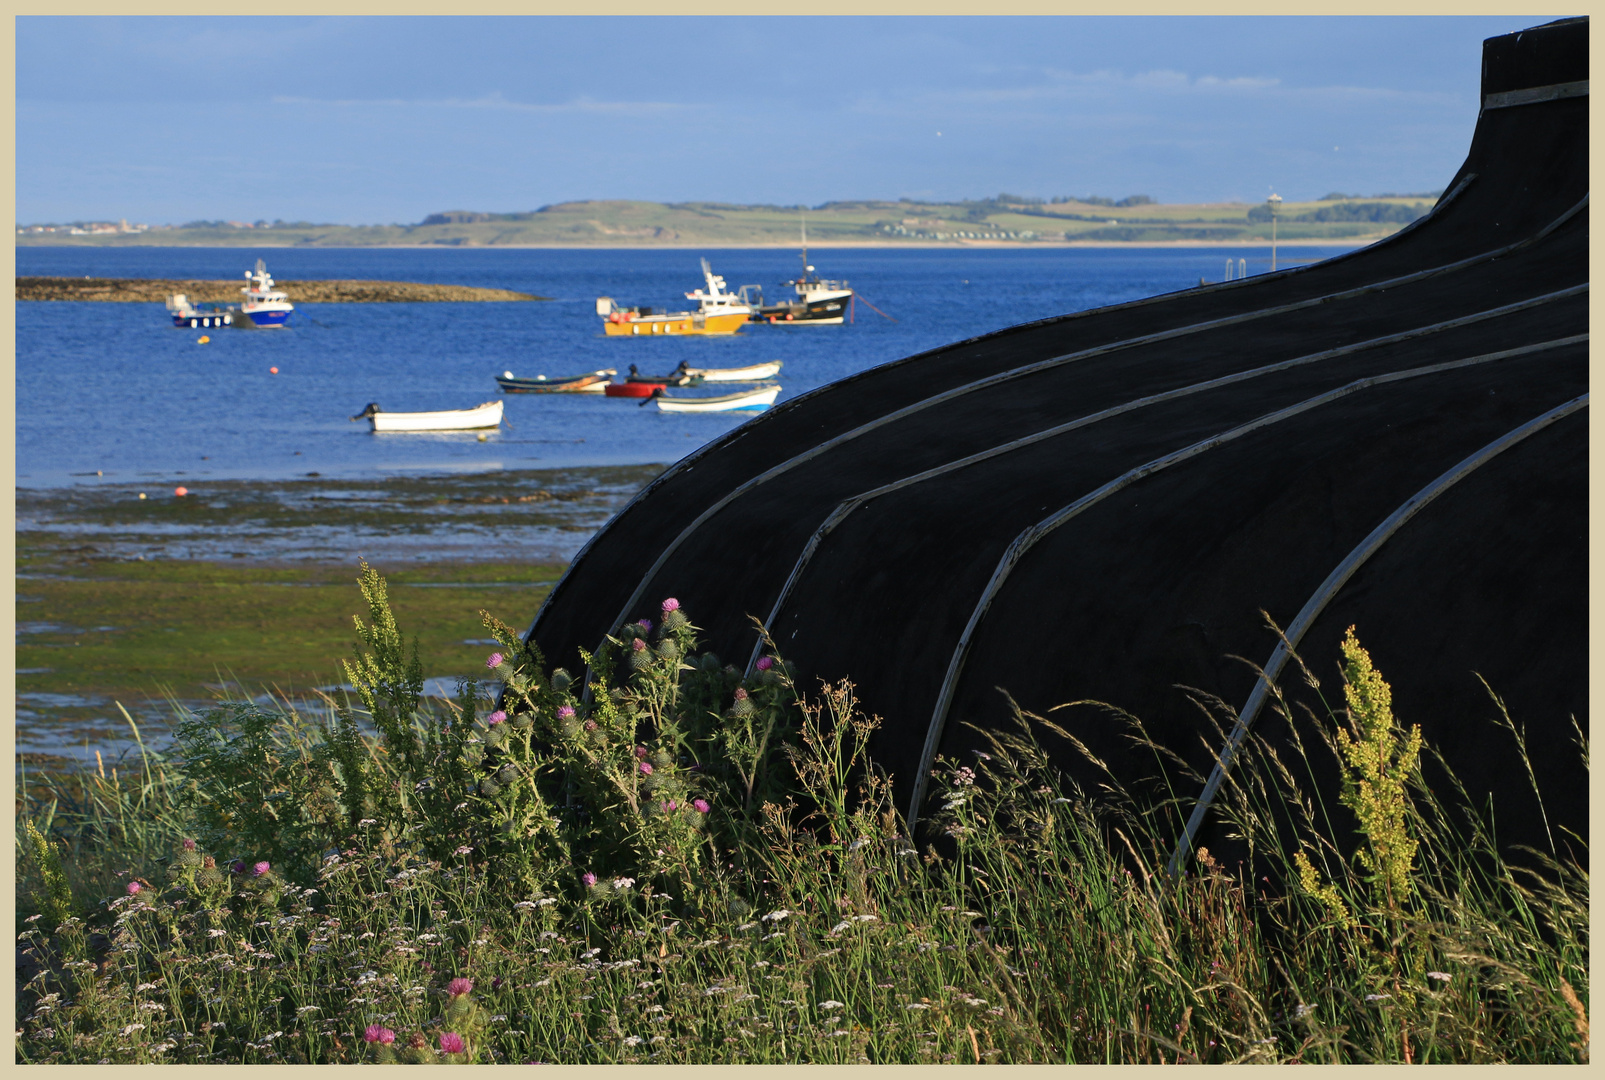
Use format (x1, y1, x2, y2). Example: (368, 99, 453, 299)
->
(16, 193, 1435, 247)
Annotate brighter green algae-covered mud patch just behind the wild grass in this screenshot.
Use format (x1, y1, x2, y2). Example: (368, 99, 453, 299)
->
(16, 560, 563, 748)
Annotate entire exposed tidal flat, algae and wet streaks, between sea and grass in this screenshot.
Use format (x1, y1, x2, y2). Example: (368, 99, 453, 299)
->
(16, 465, 661, 757)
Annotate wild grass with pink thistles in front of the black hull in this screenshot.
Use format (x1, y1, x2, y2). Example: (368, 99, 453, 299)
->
(18, 568, 1587, 1064)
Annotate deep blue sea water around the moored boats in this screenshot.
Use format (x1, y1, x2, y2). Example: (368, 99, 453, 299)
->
(16, 247, 1348, 488)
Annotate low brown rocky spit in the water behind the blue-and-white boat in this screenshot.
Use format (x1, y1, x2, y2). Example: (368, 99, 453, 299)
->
(16, 278, 546, 303)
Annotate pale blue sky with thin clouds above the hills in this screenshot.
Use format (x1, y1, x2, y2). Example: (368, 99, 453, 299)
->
(16, 16, 1554, 225)
